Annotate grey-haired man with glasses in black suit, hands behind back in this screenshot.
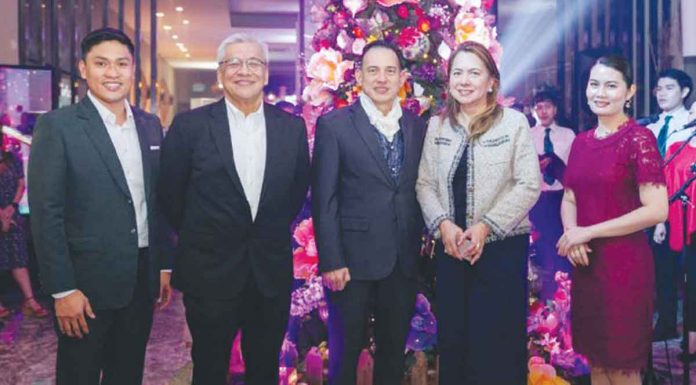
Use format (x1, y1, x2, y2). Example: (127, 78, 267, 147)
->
(160, 34, 309, 385)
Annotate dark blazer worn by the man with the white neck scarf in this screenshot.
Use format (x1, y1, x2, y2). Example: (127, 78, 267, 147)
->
(312, 102, 425, 280)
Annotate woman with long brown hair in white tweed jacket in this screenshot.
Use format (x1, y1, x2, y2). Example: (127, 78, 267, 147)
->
(416, 42, 540, 385)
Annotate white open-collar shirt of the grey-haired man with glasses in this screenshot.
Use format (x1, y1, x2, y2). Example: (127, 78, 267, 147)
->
(225, 99, 266, 220)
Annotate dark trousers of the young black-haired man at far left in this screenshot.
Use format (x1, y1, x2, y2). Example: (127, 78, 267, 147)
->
(56, 249, 153, 385)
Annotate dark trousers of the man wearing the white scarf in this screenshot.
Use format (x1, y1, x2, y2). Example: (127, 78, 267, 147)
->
(326, 266, 417, 385)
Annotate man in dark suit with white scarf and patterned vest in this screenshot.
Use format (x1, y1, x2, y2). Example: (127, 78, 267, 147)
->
(312, 41, 425, 385)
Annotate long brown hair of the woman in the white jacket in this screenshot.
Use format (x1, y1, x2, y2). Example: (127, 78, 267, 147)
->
(443, 41, 503, 141)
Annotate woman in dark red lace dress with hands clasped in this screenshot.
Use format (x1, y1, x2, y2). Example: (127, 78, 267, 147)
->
(558, 56, 667, 385)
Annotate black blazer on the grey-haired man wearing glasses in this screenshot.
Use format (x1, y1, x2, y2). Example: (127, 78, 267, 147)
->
(159, 99, 309, 299)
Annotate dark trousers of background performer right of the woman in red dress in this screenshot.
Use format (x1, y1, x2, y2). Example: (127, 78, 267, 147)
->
(648, 224, 680, 334)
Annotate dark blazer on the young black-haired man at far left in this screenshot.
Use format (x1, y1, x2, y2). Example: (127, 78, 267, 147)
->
(28, 98, 171, 309)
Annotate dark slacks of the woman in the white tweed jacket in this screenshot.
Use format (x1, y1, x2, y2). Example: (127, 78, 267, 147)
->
(436, 235, 529, 385)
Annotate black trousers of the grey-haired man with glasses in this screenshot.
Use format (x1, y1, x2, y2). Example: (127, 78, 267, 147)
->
(184, 277, 290, 385)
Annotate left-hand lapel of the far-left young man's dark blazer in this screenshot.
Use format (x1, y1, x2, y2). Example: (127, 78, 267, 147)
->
(77, 98, 130, 197)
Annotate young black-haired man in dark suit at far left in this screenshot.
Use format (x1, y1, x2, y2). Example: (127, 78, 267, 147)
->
(29, 28, 171, 385)
